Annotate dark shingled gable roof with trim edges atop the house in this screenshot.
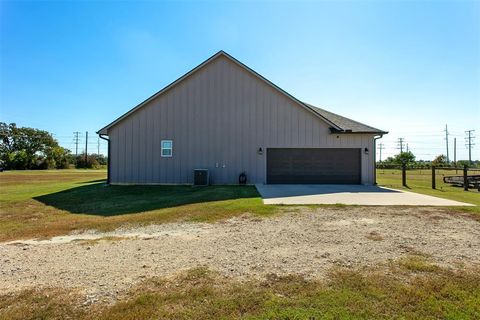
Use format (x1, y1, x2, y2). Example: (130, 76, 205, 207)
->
(97, 50, 386, 135)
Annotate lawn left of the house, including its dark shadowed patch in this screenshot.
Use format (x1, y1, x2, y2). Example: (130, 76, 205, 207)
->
(0, 170, 278, 241)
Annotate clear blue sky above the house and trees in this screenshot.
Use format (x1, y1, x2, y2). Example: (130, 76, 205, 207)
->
(0, 0, 480, 160)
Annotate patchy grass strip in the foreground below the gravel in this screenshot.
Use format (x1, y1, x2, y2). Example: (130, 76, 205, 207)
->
(0, 257, 480, 320)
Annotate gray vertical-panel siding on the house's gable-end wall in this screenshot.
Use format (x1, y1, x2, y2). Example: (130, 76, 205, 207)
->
(108, 57, 374, 184)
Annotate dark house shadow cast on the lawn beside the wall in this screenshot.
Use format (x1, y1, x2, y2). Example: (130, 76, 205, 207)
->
(34, 183, 259, 216)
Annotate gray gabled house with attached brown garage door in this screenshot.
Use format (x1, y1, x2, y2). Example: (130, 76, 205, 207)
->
(97, 51, 386, 184)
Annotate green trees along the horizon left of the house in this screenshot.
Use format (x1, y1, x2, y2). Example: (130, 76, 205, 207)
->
(0, 122, 107, 170)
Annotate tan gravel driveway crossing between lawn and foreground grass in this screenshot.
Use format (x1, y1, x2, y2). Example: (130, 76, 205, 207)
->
(0, 207, 480, 302)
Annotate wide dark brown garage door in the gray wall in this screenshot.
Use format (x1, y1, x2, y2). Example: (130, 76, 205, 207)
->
(267, 148, 361, 184)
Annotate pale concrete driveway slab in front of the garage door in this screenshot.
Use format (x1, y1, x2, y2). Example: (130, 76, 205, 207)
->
(256, 184, 473, 206)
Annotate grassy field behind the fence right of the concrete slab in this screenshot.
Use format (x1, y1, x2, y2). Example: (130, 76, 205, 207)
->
(377, 169, 480, 211)
